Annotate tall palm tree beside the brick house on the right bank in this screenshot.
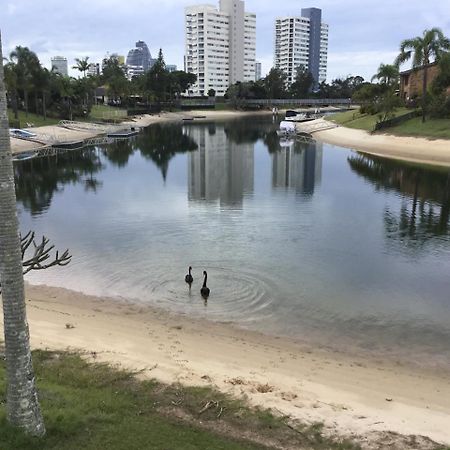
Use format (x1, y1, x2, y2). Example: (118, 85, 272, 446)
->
(395, 28, 450, 122)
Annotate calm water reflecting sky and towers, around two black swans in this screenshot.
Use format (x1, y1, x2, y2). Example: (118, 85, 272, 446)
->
(15, 119, 450, 366)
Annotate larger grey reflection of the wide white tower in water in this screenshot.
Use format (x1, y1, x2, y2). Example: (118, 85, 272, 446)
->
(183, 124, 254, 209)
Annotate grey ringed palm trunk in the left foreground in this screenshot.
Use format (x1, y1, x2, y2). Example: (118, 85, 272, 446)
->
(0, 30, 45, 436)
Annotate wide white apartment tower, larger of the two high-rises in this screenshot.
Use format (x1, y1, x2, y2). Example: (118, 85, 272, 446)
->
(185, 0, 256, 96)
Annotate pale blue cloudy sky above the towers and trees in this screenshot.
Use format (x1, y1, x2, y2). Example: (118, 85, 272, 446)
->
(0, 0, 450, 81)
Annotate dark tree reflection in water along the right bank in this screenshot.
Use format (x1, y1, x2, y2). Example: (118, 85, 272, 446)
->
(348, 154, 450, 250)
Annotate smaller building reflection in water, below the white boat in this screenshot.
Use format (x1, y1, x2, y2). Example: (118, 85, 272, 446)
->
(272, 139, 323, 195)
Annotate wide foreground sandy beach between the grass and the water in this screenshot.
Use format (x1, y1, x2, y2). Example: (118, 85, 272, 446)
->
(1, 286, 450, 444)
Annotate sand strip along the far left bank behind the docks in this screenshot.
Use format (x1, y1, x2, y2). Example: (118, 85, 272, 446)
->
(11, 110, 272, 154)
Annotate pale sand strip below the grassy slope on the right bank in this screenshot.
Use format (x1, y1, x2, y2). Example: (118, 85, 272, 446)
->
(313, 119, 450, 166)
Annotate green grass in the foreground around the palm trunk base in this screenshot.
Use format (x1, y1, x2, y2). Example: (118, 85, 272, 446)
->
(0, 351, 359, 450)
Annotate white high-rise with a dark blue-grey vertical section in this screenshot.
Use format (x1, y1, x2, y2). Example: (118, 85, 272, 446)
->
(275, 8, 328, 88)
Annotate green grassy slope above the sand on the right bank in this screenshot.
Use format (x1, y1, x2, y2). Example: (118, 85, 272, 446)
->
(326, 108, 450, 139)
